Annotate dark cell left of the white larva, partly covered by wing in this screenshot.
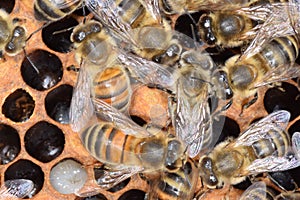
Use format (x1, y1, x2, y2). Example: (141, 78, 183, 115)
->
(4, 159, 44, 198)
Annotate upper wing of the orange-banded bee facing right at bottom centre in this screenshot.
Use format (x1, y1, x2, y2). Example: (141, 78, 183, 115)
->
(93, 98, 152, 138)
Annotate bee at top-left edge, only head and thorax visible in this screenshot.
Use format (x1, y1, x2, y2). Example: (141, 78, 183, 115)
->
(0, 9, 26, 58)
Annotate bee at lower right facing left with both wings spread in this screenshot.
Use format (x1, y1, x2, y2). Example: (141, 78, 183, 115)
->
(199, 110, 300, 188)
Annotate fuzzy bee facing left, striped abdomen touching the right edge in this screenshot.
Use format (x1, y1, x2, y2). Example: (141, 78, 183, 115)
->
(220, 36, 300, 111)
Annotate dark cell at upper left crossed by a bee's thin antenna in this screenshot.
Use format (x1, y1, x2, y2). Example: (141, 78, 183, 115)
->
(42, 17, 78, 53)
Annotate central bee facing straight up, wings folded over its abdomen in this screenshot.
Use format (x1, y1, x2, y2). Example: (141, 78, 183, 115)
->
(169, 50, 225, 158)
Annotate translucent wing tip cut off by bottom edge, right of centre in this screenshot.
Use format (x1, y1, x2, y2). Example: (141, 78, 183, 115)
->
(240, 181, 267, 200)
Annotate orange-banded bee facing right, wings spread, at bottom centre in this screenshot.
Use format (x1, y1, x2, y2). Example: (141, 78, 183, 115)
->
(80, 99, 186, 188)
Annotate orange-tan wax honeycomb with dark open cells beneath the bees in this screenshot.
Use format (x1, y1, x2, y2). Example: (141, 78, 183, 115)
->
(0, 0, 300, 200)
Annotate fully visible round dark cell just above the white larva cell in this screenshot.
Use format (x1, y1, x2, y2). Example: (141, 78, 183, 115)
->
(24, 121, 65, 163)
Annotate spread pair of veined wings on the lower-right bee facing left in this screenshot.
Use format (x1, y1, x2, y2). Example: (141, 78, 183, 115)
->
(233, 110, 300, 175)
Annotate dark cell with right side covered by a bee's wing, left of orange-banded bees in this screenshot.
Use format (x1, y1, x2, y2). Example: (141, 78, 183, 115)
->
(45, 84, 73, 124)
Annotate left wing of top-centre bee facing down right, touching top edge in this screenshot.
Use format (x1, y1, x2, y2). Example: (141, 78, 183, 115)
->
(85, 0, 136, 44)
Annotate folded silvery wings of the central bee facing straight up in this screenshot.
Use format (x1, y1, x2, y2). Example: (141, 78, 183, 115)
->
(174, 77, 212, 158)
